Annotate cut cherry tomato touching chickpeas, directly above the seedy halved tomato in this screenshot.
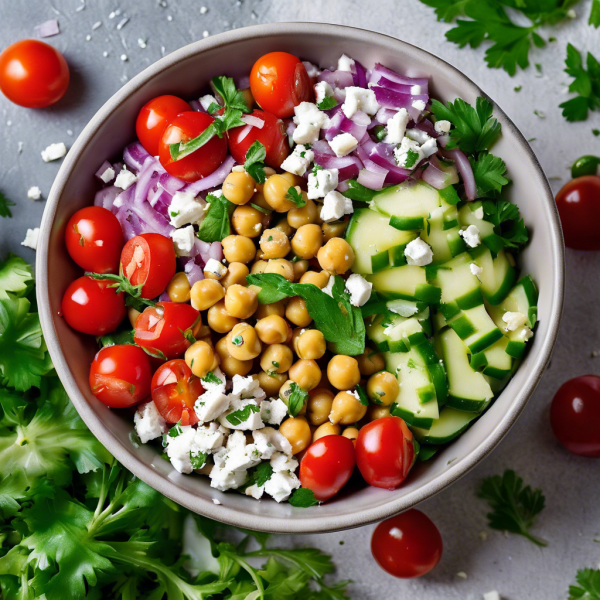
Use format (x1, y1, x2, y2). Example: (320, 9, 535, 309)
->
(133, 302, 202, 360)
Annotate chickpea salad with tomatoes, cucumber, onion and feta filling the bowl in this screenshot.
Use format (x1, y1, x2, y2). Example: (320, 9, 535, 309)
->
(62, 52, 538, 506)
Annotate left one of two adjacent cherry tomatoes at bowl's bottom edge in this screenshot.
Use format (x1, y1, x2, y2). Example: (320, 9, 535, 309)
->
(300, 435, 355, 502)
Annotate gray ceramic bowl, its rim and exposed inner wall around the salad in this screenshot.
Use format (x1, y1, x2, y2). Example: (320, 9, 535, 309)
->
(37, 23, 564, 533)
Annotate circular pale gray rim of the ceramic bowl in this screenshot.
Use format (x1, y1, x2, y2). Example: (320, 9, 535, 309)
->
(36, 22, 565, 533)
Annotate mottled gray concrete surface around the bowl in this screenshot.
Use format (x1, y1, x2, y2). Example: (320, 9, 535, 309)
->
(0, 0, 600, 600)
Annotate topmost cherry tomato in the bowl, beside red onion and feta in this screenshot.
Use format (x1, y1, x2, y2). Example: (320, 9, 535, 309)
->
(250, 52, 314, 119)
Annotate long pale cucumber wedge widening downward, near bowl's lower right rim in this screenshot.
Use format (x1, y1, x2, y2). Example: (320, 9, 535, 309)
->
(439, 328, 494, 412)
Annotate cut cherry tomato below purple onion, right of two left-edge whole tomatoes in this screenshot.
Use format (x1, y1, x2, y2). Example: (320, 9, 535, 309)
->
(121, 233, 177, 298)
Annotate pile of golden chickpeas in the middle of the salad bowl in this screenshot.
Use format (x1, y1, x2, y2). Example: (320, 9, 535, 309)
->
(152, 167, 399, 454)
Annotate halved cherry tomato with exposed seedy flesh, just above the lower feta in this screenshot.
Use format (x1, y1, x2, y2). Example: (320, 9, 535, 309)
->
(152, 358, 204, 425)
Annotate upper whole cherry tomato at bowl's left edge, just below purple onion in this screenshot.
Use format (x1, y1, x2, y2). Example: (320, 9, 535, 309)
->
(65, 206, 123, 273)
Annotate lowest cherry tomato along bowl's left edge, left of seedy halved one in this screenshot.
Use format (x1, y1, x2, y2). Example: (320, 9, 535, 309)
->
(90, 344, 152, 408)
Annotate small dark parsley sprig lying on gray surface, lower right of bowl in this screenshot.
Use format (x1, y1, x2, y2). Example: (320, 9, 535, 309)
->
(477, 470, 547, 546)
